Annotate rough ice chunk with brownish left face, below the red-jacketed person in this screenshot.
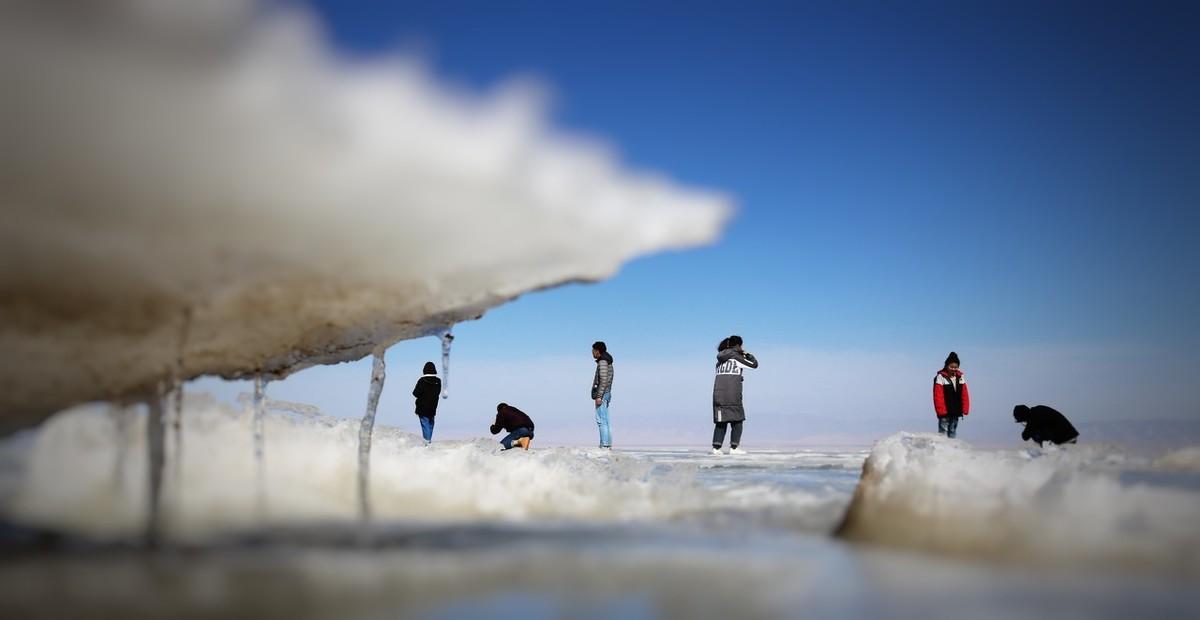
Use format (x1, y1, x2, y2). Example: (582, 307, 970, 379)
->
(841, 433, 1200, 577)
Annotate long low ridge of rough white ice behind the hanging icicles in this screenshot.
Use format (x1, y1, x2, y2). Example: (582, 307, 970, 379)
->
(0, 393, 846, 540)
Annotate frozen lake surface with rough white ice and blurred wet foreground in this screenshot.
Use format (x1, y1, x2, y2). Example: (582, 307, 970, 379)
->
(0, 402, 1200, 619)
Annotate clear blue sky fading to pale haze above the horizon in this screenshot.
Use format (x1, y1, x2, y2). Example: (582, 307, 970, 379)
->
(199, 0, 1200, 443)
